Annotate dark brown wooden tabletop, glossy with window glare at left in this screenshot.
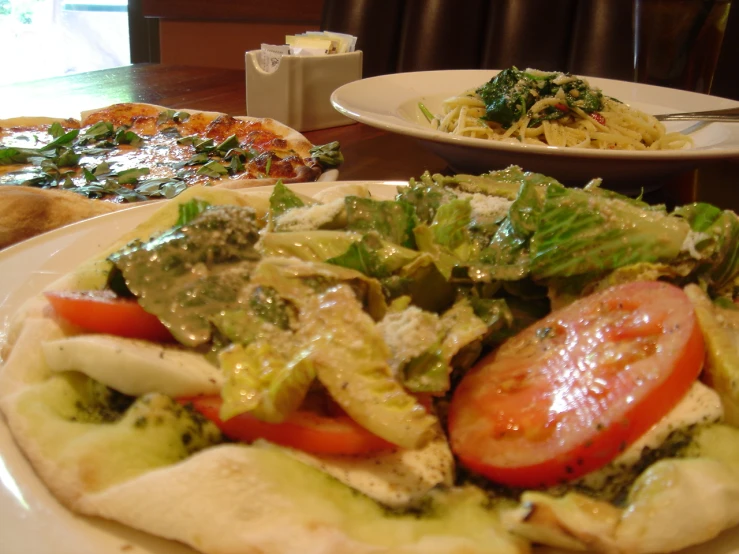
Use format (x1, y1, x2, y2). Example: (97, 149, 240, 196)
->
(0, 64, 739, 211)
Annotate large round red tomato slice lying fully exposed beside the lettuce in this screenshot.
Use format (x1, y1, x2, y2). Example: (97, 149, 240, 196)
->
(449, 282, 704, 488)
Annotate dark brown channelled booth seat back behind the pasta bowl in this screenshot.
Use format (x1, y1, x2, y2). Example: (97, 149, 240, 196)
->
(321, 0, 739, 99)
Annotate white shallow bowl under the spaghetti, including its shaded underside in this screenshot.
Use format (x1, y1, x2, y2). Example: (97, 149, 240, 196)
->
(331, 69, 739, 184)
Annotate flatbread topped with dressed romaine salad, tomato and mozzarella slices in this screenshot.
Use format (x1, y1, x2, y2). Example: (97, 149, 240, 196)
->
(0, 166, 739, 554)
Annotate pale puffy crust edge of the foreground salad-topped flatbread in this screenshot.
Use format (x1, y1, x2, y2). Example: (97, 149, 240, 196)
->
(0, 183, 739, 554)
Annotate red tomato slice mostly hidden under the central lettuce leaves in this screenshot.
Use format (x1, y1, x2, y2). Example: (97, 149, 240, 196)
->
(180, 396, 394, 454)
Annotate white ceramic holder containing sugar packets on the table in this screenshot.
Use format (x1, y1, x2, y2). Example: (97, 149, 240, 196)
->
(246, 50, 362, 131)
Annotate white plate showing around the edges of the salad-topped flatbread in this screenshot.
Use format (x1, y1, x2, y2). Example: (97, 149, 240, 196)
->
(0, 178, 739, 554)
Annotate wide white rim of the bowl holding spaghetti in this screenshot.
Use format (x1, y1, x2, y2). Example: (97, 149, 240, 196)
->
(331, 69, 739, 163)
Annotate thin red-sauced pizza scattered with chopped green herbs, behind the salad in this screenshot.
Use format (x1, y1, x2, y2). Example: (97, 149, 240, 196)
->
(0, 104, 342, 246)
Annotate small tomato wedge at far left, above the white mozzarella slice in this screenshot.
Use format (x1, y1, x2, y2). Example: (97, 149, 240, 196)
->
(44, 291, 172, 342)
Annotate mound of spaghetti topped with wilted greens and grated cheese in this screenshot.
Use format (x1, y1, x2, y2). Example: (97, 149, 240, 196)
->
(431, 67, 692, 150)
